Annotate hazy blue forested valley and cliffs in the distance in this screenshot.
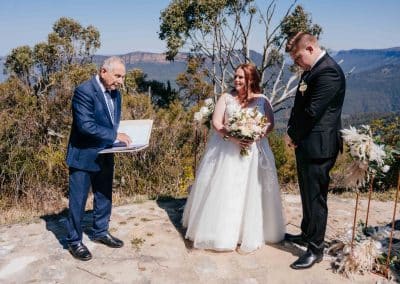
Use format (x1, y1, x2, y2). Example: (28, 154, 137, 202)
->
(0, 47, 400, 115)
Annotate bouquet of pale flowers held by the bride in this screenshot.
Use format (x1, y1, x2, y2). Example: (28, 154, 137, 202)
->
(226, 108, 270, 156)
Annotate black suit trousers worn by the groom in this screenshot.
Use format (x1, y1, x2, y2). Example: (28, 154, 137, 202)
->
(296, 151, 337, 250)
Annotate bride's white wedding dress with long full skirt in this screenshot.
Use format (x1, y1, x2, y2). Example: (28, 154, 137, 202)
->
(182, 94, 285, 252)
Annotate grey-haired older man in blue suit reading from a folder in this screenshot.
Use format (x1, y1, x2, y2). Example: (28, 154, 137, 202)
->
(66, 57, 132, 260)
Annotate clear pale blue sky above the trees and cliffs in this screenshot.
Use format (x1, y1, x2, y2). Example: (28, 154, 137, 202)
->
(0, 0, 400, 56)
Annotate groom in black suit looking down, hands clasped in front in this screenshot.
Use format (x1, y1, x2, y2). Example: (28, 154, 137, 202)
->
(285, 32, 346, 269)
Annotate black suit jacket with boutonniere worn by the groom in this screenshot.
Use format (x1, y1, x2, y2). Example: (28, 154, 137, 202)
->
(287, 54, 346, 159)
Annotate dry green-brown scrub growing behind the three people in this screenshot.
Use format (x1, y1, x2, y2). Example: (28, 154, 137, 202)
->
(0, 71, 399, 217)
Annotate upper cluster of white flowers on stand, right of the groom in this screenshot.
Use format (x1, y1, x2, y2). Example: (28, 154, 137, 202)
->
(341, 125, 390, 188)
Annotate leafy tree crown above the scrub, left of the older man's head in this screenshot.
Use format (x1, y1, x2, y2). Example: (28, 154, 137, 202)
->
(5, 17, 100, 95)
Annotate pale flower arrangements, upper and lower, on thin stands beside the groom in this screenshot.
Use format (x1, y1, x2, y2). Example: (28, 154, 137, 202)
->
(328, 125, 400, 277)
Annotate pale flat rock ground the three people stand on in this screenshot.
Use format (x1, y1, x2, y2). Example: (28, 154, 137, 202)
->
(0, 194, 394, 284)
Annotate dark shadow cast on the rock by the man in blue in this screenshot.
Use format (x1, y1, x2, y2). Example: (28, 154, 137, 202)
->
(40, 209, 93, 249)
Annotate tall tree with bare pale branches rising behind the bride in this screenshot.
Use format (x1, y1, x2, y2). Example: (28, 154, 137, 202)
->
(159, 0, 321, 111)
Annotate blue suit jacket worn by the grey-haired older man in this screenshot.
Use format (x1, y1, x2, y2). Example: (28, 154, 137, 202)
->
(66, 77, 121, 171)
